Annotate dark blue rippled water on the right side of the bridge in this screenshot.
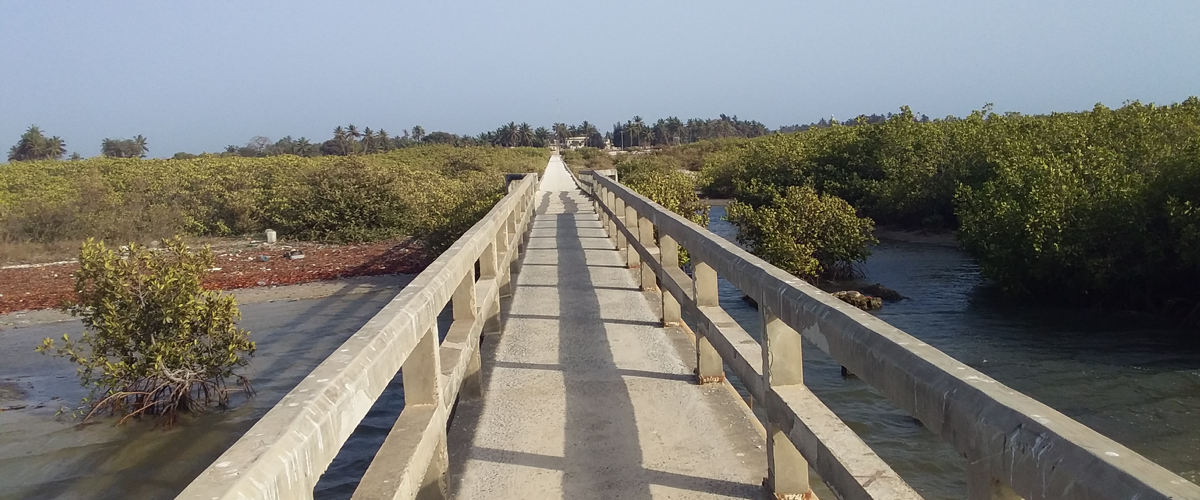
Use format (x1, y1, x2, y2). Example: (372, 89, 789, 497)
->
(709, 206, 1200, 500)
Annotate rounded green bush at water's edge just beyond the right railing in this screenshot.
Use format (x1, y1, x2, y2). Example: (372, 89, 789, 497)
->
(726, 186, 876, 281)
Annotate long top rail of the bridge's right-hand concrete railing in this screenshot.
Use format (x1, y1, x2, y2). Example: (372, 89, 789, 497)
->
(581, 171, 1200, 500)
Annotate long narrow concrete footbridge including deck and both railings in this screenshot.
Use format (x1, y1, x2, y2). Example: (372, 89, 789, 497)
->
(180, 156, 1200, 500)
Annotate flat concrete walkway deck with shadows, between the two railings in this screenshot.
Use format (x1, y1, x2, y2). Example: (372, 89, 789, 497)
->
(449, 156, 766, 499)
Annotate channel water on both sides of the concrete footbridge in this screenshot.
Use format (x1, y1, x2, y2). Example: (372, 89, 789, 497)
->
(0, 206, 1200, 500)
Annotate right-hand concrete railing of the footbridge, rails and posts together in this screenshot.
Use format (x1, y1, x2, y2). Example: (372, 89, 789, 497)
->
(577, 171, 1200, 500)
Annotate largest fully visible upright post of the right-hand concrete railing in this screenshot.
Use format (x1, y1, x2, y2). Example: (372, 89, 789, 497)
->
(758, 302, 812, 499)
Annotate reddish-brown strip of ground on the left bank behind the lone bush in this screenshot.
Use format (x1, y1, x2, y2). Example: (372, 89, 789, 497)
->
(0, 240, 428, 314)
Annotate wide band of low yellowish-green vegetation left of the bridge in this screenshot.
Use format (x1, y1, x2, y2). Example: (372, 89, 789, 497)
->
(0, 145, 545, 251)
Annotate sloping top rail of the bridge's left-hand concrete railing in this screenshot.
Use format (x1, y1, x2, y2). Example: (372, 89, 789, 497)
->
(179, 174, 538, 500)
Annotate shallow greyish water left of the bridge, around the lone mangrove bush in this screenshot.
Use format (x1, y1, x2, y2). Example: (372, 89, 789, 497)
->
(0, 284, 432, 500)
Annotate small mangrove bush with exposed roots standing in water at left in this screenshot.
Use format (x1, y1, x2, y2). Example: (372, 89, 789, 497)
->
(37, 237, 254, 426)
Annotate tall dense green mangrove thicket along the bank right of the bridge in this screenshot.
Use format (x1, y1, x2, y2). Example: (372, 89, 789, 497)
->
(702, 97, 1200, 323)
